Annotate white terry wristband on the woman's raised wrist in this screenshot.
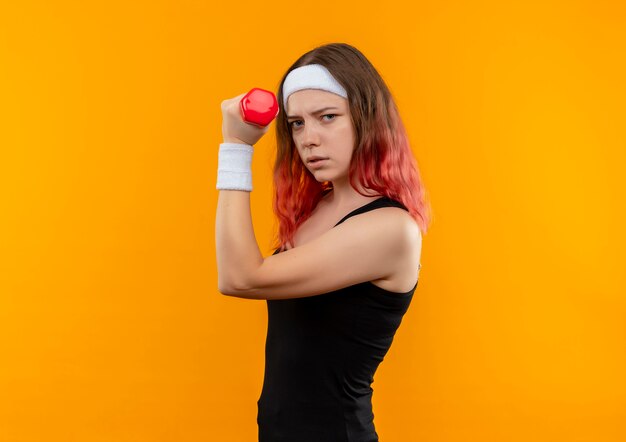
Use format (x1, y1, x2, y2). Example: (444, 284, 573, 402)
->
(215, 143, 253, 192)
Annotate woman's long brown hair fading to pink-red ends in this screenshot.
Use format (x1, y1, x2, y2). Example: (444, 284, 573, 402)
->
(273, 43, 431, 251)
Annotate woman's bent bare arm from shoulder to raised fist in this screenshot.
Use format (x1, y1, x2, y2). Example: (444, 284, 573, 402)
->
(215, 96, 421, 299)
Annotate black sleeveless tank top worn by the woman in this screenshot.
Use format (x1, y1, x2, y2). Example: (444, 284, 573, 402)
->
(257, 197, 417, 442)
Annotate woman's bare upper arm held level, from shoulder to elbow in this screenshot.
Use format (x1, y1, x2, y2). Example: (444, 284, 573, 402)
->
(224, 207, 419, 299)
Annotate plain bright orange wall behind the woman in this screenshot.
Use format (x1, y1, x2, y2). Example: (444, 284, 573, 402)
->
(0, 0, 626, 442)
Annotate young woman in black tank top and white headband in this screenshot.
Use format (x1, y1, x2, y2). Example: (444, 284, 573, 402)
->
(216, 44, 430, 442)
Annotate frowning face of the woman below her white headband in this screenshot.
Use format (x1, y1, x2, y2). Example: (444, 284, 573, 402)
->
(286, 89, 355, 182)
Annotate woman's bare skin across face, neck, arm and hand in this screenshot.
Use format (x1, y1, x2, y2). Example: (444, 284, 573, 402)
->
(215, 89, 421, 299)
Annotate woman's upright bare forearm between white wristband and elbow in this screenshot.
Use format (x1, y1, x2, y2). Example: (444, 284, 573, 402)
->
(215, 190, 263, 294)
